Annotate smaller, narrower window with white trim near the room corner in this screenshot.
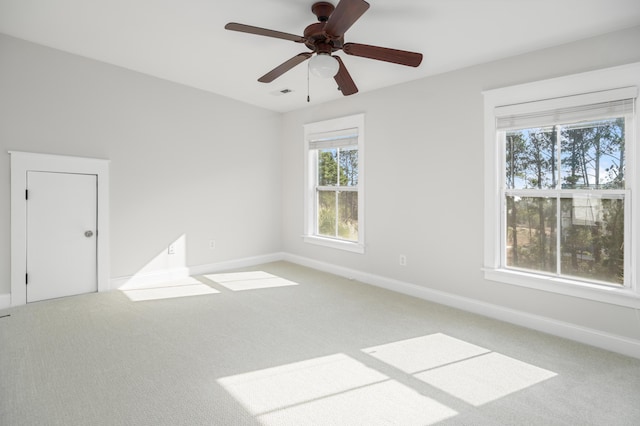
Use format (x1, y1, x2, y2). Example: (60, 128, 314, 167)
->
(305, 114, 364, 253)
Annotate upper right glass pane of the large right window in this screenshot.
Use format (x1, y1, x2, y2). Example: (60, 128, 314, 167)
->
(561, 118, 625, 189)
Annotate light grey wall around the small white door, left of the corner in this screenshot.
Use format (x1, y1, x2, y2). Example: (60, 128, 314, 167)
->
(0, 35, 281, 294)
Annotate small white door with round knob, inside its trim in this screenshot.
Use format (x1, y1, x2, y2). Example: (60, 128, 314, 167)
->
(26, 171, 98, 302)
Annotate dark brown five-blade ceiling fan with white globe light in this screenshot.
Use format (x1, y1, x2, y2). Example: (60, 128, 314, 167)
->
(225, 0, 422, 96)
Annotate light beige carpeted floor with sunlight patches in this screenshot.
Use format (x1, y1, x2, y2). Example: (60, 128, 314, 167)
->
(0, 262, 640, 426)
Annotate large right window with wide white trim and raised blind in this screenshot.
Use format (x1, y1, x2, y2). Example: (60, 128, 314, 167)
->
(484, 64, 640, 306)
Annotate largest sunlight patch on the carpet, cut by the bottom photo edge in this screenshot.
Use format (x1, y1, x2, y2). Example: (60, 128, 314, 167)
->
(218, 354, 457, 425)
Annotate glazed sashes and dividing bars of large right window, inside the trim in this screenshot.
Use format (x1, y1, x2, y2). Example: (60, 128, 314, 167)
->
(498, 114, 632, 286)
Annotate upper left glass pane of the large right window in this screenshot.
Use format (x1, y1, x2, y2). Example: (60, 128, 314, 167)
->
(505, 127, 557, 189)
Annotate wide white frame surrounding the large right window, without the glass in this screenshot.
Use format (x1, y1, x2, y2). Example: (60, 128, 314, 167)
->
(483, 63, 640, 308)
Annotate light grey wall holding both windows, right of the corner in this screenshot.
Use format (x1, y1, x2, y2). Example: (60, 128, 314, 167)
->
(283, 27, 640, 341)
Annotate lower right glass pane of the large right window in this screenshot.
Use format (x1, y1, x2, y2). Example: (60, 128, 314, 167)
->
(561, 197, 624, 284)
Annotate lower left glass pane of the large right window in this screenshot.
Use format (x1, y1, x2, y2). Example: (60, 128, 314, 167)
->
(506, 196, 557, 272)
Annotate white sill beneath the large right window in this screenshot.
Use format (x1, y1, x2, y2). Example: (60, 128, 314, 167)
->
(483, 268, 640, 309)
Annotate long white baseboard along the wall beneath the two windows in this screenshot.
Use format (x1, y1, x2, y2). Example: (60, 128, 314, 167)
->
(283, 254, 640, 358)
